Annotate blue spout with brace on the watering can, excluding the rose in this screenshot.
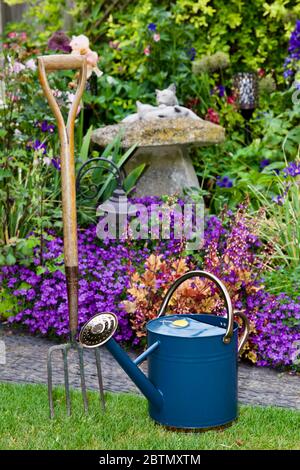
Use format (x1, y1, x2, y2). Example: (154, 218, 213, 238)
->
(105, 338, 163, 409)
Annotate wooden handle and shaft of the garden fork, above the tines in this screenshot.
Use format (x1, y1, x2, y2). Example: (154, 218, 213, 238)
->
(38, 55, 87, 341)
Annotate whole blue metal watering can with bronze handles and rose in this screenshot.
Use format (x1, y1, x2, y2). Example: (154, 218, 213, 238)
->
(79, 271, 249, 429)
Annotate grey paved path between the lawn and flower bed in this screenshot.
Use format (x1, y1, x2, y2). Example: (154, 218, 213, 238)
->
(0, 327, 300, 409)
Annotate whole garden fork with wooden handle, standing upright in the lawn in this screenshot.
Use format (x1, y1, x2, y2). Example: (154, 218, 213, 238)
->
(38, 55, 105, 418)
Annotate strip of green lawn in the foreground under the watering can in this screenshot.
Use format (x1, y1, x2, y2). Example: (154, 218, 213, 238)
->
(0, 384, 300, 450)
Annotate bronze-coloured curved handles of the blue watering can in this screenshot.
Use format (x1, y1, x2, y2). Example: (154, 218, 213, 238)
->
(157, 271, 249, 352)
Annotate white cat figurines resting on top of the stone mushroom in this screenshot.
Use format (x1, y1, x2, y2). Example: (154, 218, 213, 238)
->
(122, 83, 201, 123)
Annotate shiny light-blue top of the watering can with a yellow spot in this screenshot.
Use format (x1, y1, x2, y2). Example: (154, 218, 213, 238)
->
(147, 314, 227, 338)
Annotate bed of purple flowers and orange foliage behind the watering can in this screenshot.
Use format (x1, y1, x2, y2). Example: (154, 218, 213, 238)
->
(0, 200, 300, 370)
